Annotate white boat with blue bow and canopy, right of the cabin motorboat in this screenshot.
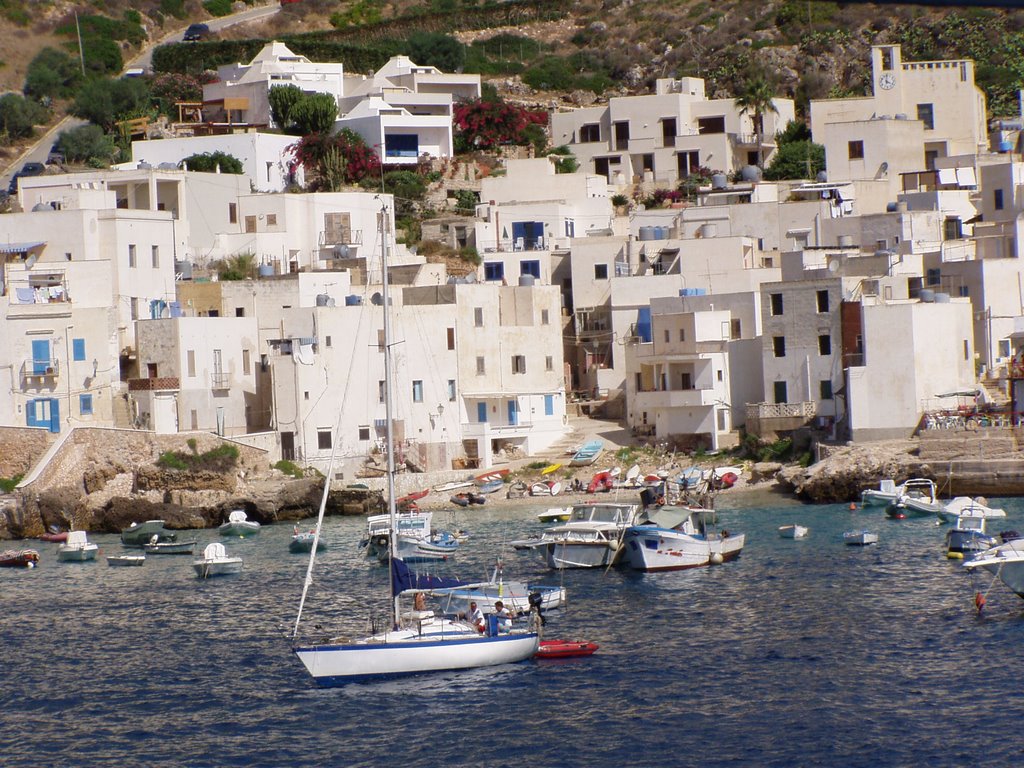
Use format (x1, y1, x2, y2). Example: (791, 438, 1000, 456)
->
(623, 506, 745, 571)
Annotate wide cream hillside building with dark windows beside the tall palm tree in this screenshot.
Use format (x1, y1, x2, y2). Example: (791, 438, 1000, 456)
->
(551, 78, 796, 187)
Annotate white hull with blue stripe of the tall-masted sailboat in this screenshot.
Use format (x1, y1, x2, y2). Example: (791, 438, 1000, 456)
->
(295, 623, 541, 687)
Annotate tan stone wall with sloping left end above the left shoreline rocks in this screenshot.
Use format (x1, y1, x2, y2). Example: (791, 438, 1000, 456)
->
(23, 427, 269, 494)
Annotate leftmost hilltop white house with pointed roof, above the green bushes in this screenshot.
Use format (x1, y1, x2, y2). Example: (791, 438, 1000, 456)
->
(203, 41, 344, 127)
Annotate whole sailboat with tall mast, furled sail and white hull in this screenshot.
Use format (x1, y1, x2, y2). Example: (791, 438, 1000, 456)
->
(292, 201, 541, 686)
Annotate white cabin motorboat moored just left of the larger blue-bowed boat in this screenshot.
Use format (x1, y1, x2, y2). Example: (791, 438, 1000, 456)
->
(512, 502, 640, 569)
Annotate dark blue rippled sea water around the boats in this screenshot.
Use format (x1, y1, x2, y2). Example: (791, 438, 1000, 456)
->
(6, 493, 1024, 768)
